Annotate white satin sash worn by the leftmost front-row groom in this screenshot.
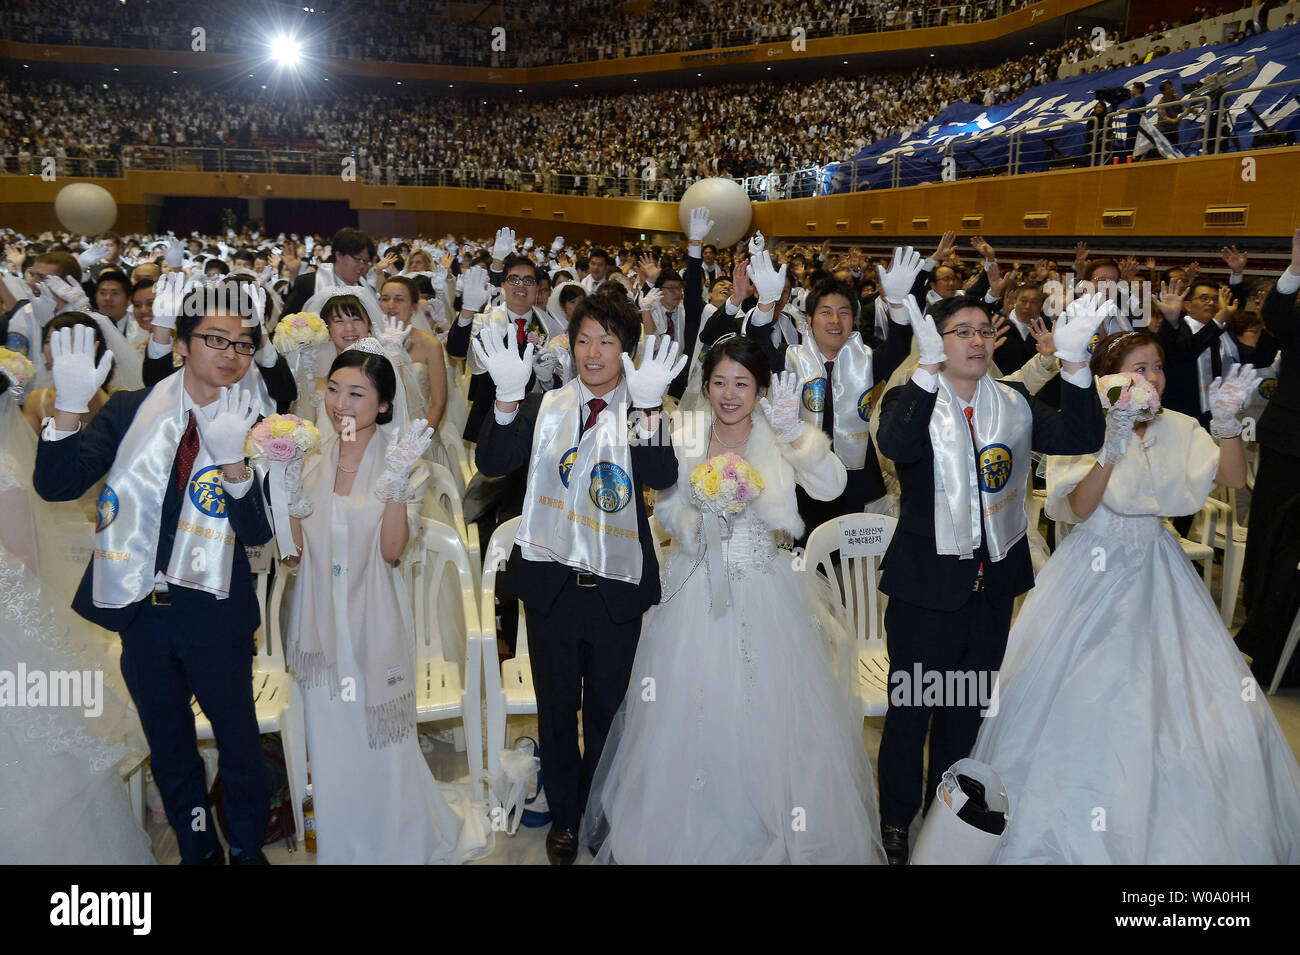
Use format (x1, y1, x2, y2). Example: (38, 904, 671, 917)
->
(91, 369, 241, 607)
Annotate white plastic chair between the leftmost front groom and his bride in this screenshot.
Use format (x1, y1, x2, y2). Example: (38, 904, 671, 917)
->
(191, 565, 307, 839)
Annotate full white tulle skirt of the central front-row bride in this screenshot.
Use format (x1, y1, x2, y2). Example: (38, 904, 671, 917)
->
(582, 508, 883, 864)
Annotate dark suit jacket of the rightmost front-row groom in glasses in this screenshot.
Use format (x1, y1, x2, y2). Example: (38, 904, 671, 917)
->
(878, 381, 1106, 611)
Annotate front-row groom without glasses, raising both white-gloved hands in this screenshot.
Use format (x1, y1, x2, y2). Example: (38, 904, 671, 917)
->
(473, 290, 686, 865)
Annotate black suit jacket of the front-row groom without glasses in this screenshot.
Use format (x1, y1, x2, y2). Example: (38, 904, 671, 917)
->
(475, 395, 677, 624)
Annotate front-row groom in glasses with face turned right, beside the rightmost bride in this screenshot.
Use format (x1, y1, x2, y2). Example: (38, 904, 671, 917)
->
(878, 295, 1113, 865)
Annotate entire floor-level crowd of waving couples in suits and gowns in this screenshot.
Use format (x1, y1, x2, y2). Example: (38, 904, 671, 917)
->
(0, 218, 1300, 864)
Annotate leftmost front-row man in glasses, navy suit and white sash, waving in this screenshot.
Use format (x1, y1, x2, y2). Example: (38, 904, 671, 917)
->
(33, 290, 272, 865)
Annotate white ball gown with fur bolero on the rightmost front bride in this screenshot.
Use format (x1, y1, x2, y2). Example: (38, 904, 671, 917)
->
(971, 409, 1300, 864)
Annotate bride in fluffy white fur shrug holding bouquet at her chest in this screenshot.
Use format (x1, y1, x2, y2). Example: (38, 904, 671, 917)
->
(582, 335, 883, 864)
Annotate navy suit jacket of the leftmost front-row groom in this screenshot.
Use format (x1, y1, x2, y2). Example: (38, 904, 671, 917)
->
(33, 388, 272, 637)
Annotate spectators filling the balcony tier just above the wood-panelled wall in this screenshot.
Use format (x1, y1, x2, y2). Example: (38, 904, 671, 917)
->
(0, 41, 1071, 197)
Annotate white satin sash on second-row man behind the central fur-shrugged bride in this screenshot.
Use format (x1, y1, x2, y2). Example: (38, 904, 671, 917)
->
(785, 331, 875, 470)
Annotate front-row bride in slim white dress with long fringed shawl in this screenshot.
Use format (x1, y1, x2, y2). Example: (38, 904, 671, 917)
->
(286, 340, 490, 864)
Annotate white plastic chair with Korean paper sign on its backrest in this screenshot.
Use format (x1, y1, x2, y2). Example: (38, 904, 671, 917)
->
(803, 513, 898, 717)
